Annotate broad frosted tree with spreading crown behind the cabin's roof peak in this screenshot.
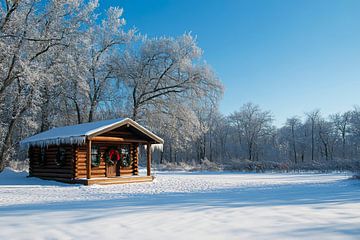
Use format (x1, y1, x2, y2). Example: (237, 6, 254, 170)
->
(114, 34, 222, 120)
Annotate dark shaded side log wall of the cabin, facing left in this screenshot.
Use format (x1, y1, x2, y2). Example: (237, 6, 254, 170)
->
(29, 145, 76, 179)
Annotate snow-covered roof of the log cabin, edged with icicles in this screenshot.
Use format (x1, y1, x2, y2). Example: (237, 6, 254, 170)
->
(20, 118, 164, 147)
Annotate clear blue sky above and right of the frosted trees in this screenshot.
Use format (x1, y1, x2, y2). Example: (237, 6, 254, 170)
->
(100, 0, 360, 125)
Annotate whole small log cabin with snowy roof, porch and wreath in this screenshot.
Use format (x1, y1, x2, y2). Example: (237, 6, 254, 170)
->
(20, 118, 164, 185)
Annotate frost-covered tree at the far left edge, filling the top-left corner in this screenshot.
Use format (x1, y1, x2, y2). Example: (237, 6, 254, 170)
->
(0, 0, 97, 170)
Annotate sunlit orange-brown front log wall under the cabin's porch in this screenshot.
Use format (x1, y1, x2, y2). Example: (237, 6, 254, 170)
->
(75, 141, 139, 178)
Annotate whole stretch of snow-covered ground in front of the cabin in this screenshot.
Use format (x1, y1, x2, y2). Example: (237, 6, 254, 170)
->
(0, 170, 360, 240)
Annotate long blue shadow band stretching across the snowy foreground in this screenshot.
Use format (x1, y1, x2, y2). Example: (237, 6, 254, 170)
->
(0, 180, 360, 217)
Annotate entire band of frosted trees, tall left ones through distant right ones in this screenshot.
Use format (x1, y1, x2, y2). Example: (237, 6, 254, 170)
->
(0, 0, 360, 171)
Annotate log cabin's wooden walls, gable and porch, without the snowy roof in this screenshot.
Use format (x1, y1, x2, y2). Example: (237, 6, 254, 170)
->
(25, 119, 163, 185)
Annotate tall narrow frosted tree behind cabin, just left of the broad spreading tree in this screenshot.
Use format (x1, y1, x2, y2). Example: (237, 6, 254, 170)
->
(85, 7, 134, 122)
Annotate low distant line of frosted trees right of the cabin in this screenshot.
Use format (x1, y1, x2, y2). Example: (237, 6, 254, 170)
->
(159, 103, 360, 170)
